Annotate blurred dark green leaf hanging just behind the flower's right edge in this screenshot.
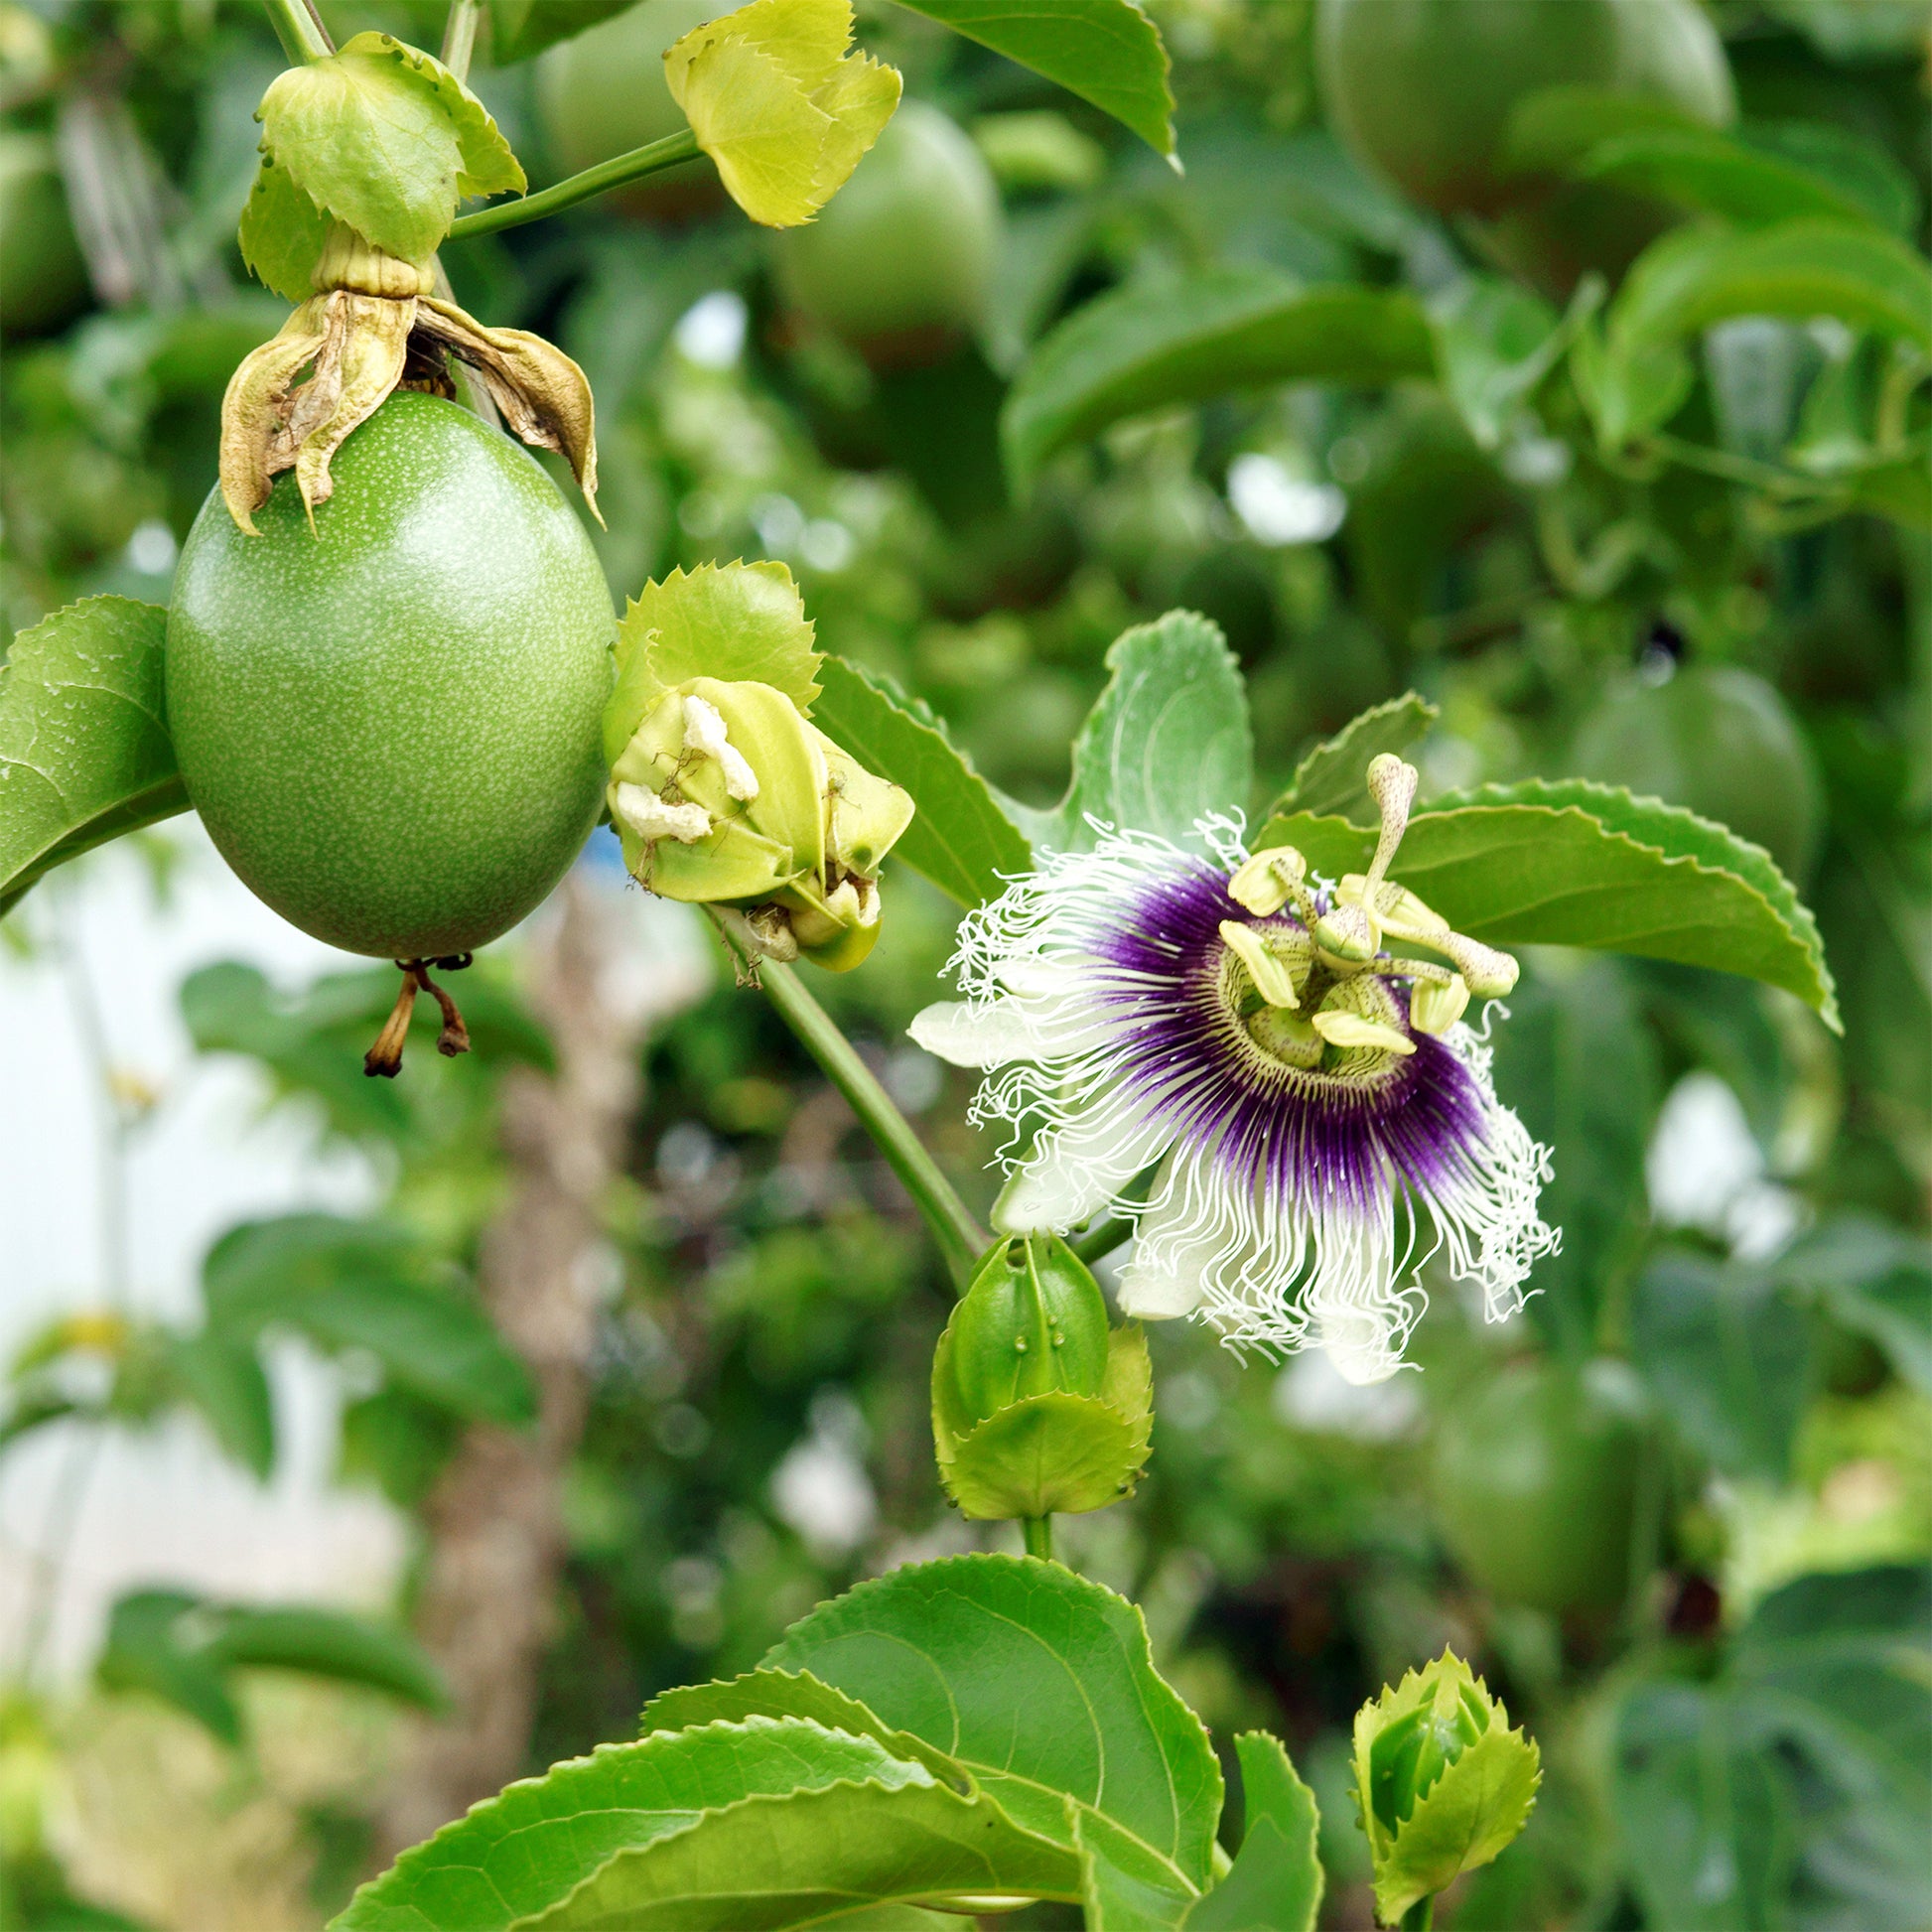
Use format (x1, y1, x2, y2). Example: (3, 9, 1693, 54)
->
(1489, 958, 1664, 1360)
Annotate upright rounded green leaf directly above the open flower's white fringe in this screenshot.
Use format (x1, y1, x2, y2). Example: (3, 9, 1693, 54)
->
(1028, 611, 1254, 852)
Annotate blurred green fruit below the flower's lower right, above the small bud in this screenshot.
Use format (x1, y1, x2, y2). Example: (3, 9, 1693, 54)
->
(1432, 1360, 1642, 1613)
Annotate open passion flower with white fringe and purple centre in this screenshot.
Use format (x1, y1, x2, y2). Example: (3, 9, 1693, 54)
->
(912, 756, 1559, 1381)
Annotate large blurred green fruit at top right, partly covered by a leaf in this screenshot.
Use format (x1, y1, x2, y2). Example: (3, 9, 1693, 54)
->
(1315, 0, 1735, 292)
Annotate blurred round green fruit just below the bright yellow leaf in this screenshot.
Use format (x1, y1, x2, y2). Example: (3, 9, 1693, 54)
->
(774, 100, 1001, 369)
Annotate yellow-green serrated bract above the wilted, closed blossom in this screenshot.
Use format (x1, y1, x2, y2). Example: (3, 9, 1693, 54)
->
(605, 562, 823, 763)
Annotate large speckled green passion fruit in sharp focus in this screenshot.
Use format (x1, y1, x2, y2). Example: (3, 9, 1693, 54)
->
(168, 392, 617, 958)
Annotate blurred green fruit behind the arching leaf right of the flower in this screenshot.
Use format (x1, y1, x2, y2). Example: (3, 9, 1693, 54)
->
(1571, 664, 1822, 883)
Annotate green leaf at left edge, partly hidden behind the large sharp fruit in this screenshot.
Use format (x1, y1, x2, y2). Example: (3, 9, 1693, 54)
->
(0, 597, 188, 913)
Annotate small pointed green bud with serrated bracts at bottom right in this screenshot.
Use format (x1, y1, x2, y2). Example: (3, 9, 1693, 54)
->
(1354, 1650, 1542, 1926)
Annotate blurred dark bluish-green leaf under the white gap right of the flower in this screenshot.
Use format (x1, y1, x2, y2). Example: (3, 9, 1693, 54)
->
(1630, 1248, 1812, 1482)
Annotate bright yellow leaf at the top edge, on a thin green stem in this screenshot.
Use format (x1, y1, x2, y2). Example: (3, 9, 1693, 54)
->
(664, 0, 900, 228)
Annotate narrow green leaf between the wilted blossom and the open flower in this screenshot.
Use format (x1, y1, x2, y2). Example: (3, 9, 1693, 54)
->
(811, 657, 1034, 906)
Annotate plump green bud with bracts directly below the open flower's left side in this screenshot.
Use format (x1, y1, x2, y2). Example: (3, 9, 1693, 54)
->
(933, 1234, 1154, 1517)
